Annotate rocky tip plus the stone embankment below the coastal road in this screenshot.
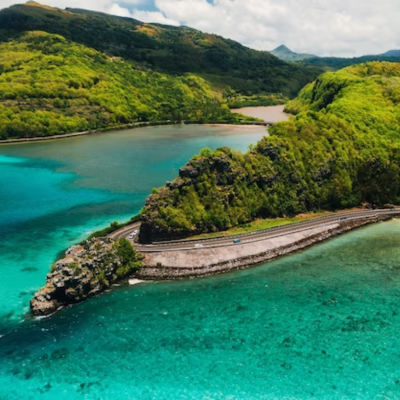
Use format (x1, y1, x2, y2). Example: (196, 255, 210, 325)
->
(30, 215, 392, 316)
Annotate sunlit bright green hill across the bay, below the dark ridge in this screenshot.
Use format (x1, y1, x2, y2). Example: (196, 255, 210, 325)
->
(0, 32, 240, 139)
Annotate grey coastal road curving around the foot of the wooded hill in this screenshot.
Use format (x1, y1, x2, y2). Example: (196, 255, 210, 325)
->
(109, 208, 400, 253)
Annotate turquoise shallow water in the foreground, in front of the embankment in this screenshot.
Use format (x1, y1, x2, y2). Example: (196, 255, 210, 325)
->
(0, 221, 400, 400)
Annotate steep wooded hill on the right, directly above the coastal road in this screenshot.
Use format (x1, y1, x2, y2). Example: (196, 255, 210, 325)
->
(140, 62, 400, 242)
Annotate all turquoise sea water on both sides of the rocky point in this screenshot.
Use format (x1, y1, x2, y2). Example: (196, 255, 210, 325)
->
(0, 127, 400, 400)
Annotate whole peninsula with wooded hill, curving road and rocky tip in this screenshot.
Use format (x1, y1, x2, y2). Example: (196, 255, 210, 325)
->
(31, 62, 400, 314)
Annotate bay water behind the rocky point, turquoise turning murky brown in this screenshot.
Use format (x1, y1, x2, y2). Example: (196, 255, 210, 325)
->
(0, 126, 266, 335)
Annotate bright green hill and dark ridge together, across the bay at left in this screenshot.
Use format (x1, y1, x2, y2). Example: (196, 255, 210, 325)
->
(0, 2, 321, 140)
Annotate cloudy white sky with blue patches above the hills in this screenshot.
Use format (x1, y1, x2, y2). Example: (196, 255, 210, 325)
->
(0, 0, 400, 57)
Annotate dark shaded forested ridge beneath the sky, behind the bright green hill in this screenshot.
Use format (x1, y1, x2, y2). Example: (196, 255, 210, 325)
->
(0, 2, 321, 97)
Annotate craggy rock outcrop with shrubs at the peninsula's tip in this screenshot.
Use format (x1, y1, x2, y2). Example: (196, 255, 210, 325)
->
(30, 238, 142, 315)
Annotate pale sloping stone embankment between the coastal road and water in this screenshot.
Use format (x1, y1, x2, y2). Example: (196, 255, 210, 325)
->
(136, 216, 391, 279)
